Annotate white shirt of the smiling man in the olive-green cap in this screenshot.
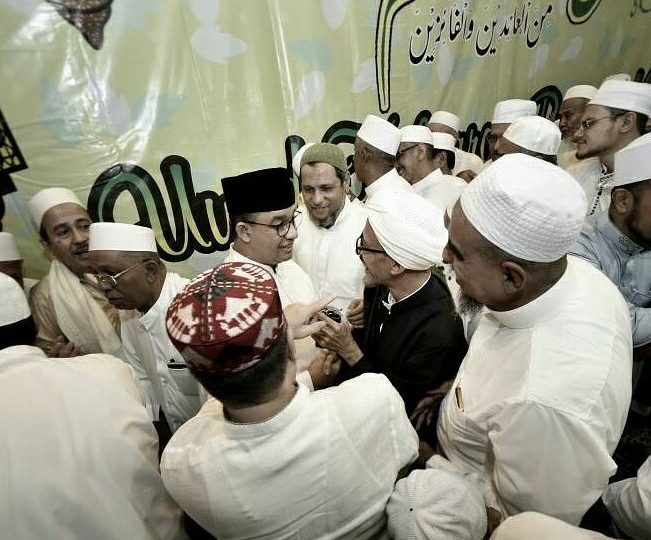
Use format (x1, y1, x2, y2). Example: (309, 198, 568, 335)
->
(293, 198, 367, 313)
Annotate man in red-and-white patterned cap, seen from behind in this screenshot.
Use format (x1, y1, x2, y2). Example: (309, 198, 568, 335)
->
(161, 263, 418, 540)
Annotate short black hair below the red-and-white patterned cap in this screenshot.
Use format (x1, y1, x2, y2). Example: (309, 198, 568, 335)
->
(188, 331, 289, 406)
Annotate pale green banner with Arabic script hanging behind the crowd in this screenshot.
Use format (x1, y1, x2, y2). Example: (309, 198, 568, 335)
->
(0, 0, 651, 276)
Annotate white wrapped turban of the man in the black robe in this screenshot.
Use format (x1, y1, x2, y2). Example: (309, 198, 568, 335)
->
(364, 190, 448, 270)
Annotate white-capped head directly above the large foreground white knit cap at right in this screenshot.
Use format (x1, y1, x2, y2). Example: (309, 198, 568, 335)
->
(495, 116, 561, 165)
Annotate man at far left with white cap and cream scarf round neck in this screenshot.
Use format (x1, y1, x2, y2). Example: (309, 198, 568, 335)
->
(28, 188, 122, 356)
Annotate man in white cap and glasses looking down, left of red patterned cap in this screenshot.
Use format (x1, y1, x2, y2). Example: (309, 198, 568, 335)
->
(88, 223, 199, 436)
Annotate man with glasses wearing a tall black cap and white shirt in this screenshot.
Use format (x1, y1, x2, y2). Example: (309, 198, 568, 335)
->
(222, 168, 317, 372)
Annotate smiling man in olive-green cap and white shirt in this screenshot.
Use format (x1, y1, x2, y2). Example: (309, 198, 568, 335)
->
(293, 143, 366, 311)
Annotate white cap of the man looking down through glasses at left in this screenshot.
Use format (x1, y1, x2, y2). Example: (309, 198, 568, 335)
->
(88, 222, 156, 253)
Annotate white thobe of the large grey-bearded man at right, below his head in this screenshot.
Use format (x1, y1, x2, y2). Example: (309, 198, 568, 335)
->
(438, 257, 632, 525)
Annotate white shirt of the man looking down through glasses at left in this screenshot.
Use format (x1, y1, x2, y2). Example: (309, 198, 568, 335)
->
(122, 272, 200, 432)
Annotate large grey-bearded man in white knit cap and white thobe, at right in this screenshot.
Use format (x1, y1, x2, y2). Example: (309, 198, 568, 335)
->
(438, 154, 632, 524)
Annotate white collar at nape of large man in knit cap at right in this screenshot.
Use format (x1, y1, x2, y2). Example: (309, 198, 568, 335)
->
(486, 257, 574, 329)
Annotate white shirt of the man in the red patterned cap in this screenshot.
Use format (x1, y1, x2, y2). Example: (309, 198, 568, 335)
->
(161, 374, 418, 540)
